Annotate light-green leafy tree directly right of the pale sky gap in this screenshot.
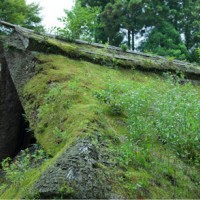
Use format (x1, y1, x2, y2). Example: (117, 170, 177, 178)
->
(57, 2, 100, 42)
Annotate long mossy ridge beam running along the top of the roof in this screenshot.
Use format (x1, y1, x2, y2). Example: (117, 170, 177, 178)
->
(25, 34, 199, 76)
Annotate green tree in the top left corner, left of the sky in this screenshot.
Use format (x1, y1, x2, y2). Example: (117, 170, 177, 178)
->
(0, 0, 42, 29)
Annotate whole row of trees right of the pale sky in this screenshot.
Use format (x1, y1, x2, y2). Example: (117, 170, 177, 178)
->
(56, 0, 200, 61)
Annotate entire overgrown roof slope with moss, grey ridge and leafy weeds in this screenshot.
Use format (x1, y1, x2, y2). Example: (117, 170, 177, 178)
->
(0, 23, 200, 199)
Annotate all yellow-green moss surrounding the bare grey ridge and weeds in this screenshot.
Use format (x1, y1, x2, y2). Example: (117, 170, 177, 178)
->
(0, 52, 199, 199)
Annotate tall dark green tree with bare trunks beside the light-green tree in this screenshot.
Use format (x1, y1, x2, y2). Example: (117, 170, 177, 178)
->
(101, 0, 143, 50)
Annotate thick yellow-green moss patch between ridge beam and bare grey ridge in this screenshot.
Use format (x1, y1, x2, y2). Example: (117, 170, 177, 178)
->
(24, 54, 161, 155)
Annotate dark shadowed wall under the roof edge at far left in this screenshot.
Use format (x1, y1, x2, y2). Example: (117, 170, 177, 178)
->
(0, 41, 30, 160)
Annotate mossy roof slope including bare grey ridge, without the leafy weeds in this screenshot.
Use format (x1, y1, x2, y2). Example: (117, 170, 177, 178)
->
(0, 54, 200, 199)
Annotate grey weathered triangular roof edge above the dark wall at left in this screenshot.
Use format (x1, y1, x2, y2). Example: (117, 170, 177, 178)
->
(4, 33, 36, 101)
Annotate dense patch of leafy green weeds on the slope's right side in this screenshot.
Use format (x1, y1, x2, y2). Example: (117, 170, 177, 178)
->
(96, 76, 200, 166)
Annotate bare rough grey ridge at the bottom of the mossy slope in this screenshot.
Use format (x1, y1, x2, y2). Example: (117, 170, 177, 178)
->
(35, 136, 119, 199)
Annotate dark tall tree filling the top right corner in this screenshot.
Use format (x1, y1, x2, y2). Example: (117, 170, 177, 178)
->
(145, 0, 200, 51)
